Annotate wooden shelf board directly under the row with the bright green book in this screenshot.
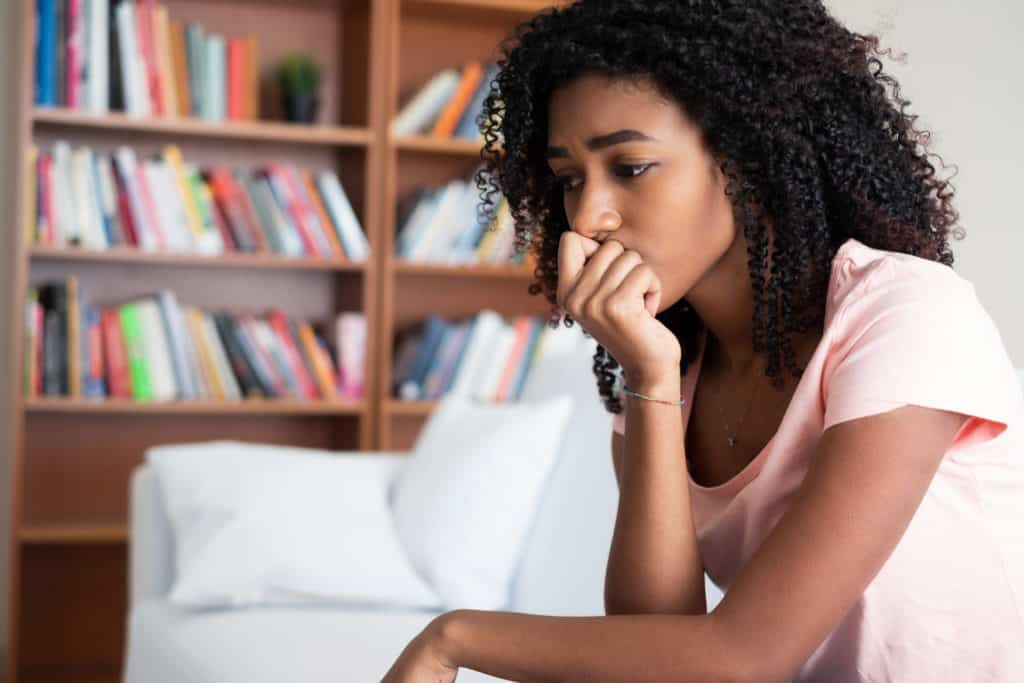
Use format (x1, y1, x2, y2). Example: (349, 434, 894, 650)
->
(25, 397, 366, 416)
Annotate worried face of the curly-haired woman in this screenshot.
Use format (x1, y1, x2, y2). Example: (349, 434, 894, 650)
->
(548, 75, 745, 310)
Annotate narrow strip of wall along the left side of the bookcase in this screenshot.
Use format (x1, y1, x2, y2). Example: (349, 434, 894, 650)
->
(0, 0, 18, 681)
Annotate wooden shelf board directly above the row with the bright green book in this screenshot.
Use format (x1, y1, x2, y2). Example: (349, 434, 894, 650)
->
(29, 246, 367, 272)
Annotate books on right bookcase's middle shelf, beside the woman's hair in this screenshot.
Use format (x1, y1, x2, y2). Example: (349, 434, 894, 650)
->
(394, 167, 526, 265)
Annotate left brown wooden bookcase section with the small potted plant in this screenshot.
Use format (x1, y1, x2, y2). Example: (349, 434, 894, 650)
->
(4, 0, 392, 682)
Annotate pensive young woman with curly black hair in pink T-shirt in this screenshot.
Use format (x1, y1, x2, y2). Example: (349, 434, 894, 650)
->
(384, 0, 1024, 683)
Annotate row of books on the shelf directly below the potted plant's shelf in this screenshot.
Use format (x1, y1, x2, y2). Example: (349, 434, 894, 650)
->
(26, 140, 370, 261)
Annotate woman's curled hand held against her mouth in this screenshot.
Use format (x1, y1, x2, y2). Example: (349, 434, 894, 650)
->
(556, 230, 682, 384)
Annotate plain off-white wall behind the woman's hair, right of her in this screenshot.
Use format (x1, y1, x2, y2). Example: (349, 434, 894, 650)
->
(825, 0, 1024, 368)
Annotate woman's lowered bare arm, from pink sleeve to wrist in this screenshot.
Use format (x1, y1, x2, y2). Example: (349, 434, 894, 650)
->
(437, 405, 966, 683)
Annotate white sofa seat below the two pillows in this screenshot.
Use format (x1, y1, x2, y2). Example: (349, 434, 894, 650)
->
(121, 599, 503, 683)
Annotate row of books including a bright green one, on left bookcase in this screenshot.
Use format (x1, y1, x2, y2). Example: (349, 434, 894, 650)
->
(24, 275, 366, 401)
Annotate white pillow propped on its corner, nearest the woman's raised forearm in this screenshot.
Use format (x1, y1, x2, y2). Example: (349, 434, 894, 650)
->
(393, 394, 573, 609)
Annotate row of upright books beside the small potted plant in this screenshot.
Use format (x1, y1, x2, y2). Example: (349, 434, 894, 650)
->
(35, 0, 259, 122)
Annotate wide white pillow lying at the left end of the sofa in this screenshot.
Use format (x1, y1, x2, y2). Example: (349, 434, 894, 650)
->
(146, 441, 440, 608)
